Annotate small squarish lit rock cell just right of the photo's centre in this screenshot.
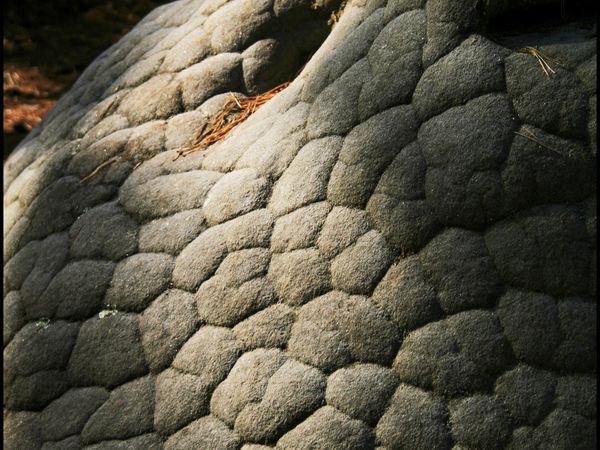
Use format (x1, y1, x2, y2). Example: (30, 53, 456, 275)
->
(317, 206, 370, 258)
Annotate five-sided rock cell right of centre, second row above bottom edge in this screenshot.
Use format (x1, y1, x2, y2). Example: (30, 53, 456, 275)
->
(325, 364, 398, 425)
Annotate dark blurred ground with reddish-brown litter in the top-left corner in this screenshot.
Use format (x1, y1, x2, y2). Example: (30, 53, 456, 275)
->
(2, 0, 170, 160)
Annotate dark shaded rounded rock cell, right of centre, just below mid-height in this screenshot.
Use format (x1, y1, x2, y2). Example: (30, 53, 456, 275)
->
(420, 228, 502, 314)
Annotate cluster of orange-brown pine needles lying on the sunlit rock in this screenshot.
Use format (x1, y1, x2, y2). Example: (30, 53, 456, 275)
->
(175, 81, 290, 159)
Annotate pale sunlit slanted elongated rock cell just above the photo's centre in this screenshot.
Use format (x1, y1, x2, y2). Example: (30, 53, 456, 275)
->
(269, 136, 342, 216)
